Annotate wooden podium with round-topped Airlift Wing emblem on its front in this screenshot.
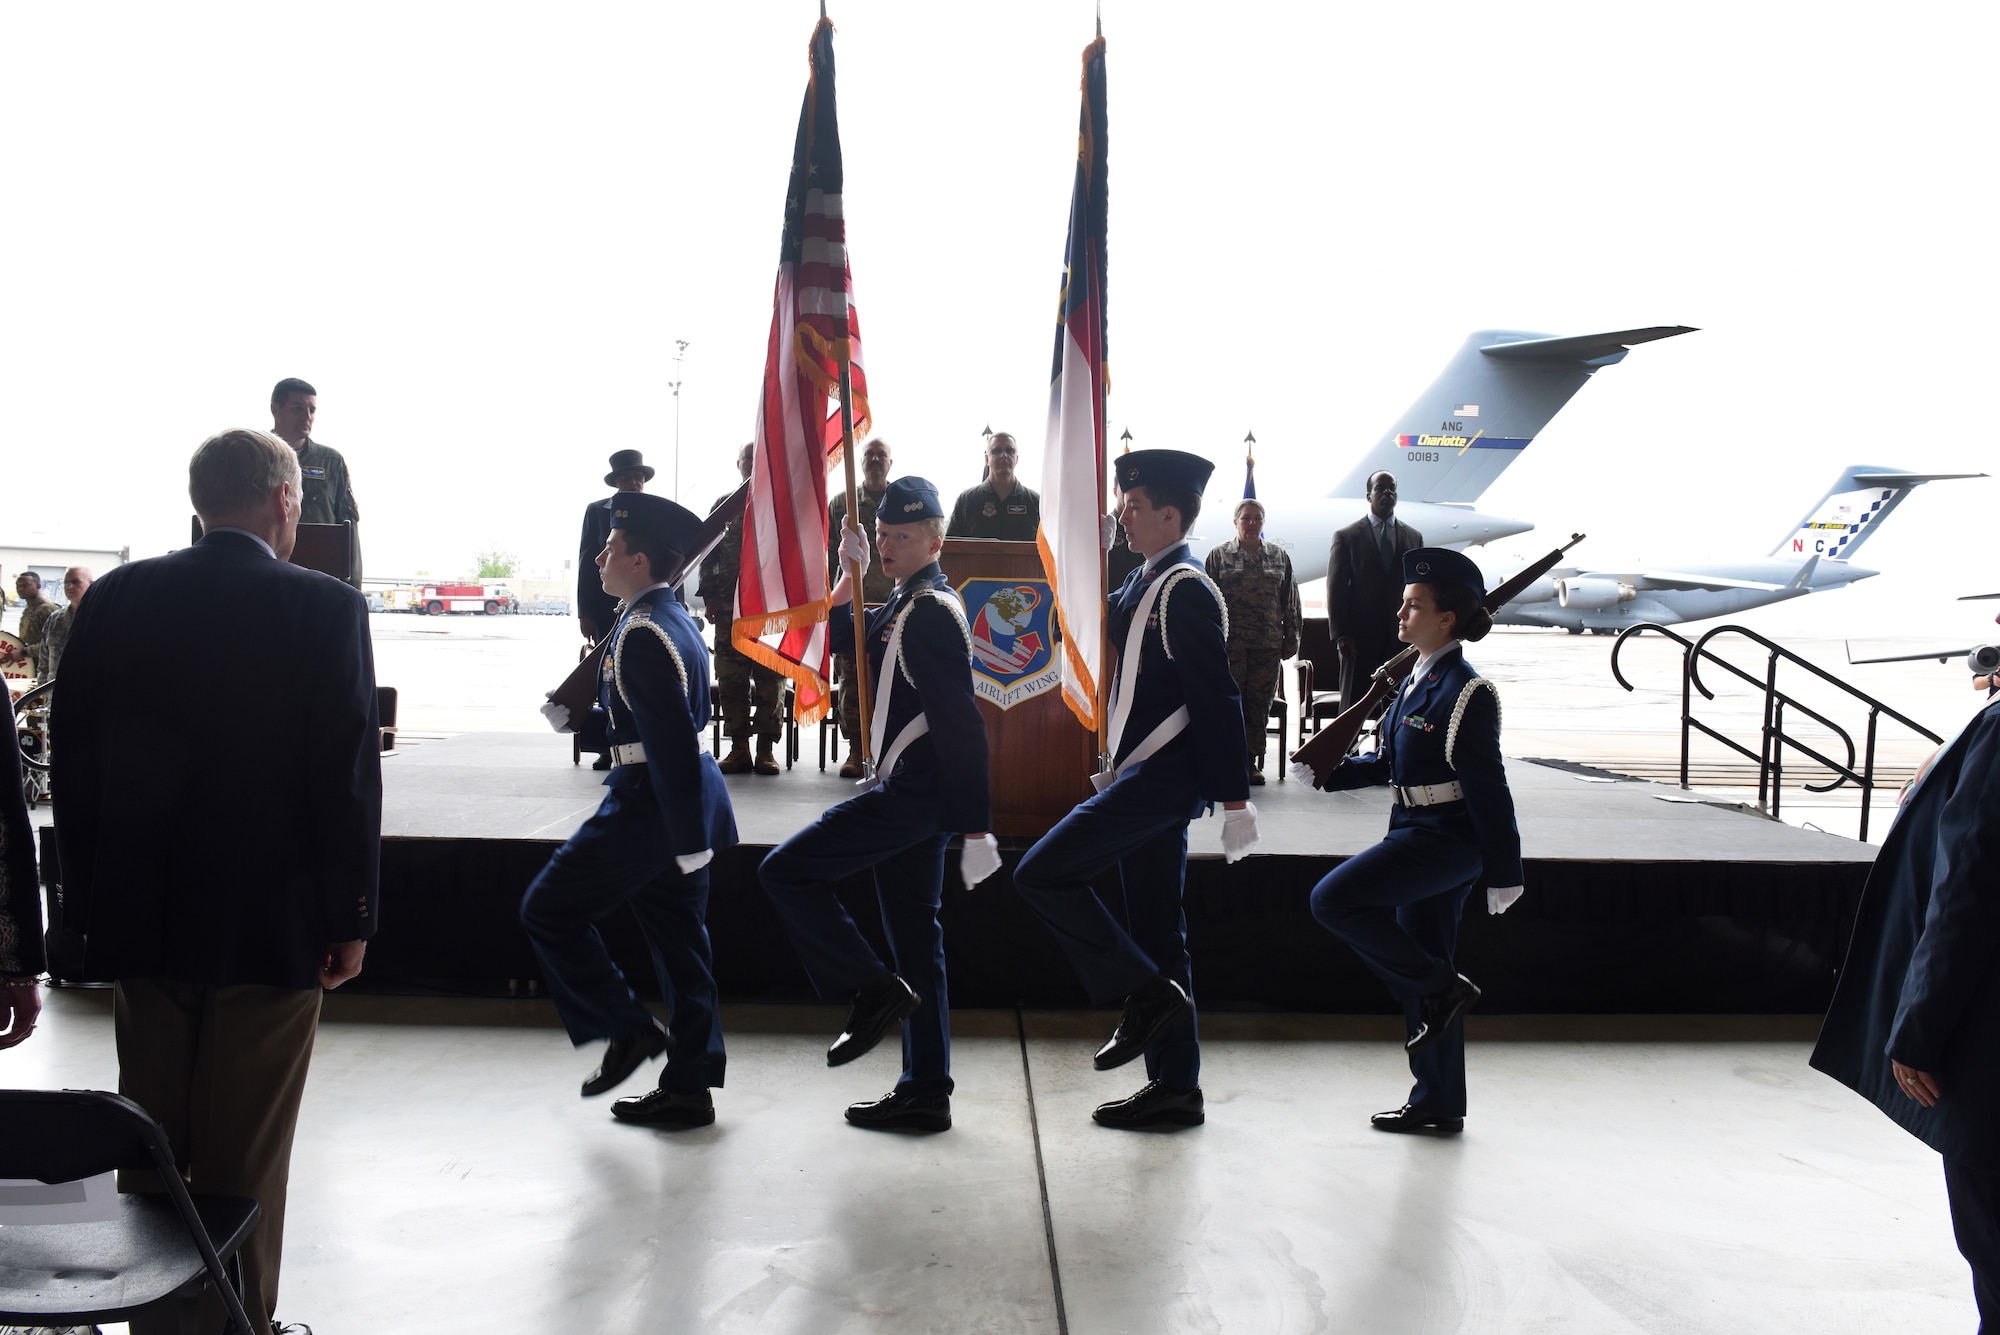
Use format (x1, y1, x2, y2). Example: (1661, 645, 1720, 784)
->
(940, 538, 1098, 837)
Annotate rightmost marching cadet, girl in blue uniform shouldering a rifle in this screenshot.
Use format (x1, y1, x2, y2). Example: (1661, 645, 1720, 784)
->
(1306, 548, 1522, 1133)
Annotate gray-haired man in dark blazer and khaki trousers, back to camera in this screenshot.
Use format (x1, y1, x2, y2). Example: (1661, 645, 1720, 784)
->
(52, 430, 382, 1333)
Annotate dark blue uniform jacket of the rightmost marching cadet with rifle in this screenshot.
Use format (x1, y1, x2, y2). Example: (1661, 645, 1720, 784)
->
(1326, 648, 1522, 887)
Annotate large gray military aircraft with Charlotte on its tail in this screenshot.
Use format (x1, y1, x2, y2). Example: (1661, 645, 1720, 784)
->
(1196, 324, 1694, 584)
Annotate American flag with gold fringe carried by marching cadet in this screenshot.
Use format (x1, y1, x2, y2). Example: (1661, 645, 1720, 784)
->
(730, 18, 868, 723)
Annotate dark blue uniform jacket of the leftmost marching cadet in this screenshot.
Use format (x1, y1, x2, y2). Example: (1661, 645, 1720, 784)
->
(576, 588, 736, 857)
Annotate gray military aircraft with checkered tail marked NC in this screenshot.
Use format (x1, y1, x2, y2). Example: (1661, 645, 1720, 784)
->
(1482, 466, 1986, 636)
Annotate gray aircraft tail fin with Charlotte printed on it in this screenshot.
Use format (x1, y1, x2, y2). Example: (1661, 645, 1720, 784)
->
(1328, 324, 1694, 506)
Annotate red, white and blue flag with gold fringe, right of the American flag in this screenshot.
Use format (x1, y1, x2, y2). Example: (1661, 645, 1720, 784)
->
(1036, 36, 1108, 729)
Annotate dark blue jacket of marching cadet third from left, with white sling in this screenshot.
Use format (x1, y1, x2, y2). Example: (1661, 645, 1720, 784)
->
(1110, 544, 1250, 811)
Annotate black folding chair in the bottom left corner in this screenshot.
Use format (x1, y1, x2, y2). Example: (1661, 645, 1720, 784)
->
(0, 1089, 262, 1335)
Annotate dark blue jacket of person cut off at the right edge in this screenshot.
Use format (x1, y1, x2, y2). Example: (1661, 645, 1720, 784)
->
(1816, 699, 2000, 1173)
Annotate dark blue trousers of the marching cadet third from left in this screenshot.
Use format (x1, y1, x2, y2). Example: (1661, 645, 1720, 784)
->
(1014, 767, 1202, 1091)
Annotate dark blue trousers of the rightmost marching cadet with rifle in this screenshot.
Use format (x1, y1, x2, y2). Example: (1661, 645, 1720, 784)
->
(1312, 823, 1482, 1117)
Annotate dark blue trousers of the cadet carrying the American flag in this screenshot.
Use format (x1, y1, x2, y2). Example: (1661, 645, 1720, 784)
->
(760, 777, 952, 1099)
